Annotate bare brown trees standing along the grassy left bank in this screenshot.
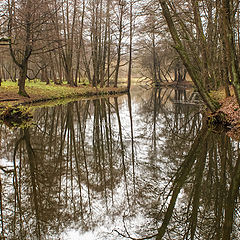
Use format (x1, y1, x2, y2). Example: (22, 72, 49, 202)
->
(1, 0, 133, 96)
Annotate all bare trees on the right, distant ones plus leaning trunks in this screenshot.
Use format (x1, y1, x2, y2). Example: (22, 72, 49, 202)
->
(137, 0, 240, 111)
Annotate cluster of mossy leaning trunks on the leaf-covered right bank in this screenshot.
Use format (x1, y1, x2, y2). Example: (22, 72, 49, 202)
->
(159, 0, 240, 111)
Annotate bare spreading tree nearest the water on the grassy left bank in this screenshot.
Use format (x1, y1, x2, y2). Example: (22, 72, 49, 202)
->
(7, 0, 55, 97)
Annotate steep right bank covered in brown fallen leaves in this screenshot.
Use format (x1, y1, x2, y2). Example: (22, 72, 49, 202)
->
(212, 88, 240, 141)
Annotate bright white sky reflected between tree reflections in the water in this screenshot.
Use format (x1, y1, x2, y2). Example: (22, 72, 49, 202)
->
(0, 87, 201, 240)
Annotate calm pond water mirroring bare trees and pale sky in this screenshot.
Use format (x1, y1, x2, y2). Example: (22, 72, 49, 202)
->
(0, 88, 240, 240)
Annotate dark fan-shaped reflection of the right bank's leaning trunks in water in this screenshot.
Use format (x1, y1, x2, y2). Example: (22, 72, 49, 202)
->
(145, 125, 240, 240)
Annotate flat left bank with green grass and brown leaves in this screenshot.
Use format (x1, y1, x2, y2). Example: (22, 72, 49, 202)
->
(0, 81, 127, 108)
